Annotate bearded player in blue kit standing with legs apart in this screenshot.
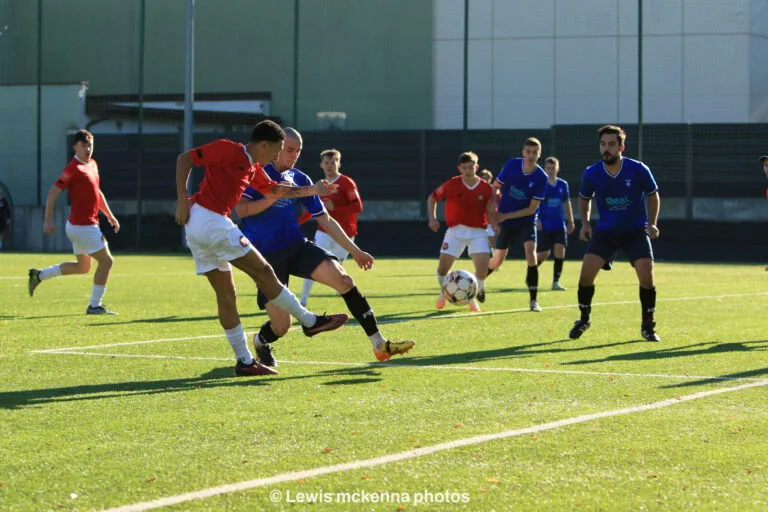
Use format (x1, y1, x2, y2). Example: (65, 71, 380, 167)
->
(569, 125, 661, 341)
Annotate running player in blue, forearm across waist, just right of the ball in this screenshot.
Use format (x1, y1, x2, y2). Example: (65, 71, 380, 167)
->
(488, 137, 547, 311)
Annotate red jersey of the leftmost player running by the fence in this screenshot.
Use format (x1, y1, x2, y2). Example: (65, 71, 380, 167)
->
(54, 158, 101, 226)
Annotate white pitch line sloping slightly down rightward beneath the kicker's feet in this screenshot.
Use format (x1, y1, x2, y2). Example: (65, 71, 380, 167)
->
(36, 349, 763, 381)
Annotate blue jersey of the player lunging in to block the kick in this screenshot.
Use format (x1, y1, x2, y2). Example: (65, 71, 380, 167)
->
(243, 164, 325, 254)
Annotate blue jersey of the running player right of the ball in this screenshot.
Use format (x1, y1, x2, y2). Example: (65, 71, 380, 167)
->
(496, 158, 549, 224)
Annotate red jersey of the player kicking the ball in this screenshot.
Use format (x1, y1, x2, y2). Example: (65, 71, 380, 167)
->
(191, 139, 277, 217)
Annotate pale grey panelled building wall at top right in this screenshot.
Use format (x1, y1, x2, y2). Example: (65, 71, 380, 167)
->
(434, 0, 768, 129)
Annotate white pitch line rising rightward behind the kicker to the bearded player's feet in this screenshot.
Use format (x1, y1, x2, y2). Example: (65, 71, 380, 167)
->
(31, 292, 768, 354)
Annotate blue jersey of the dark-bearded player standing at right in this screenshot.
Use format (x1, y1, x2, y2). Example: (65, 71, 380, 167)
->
(579, 158, 659, 235)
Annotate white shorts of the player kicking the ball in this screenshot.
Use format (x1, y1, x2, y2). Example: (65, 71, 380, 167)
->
(186, 204, 255, 275)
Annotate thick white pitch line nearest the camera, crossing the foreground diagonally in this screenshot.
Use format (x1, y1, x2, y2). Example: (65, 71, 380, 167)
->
(105, 380, 768, 512)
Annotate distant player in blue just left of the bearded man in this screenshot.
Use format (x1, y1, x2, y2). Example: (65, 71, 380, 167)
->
(536, 156, 574, 291)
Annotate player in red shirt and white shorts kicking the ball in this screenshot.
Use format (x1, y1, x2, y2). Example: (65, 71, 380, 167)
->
(176, 121, 349, 376)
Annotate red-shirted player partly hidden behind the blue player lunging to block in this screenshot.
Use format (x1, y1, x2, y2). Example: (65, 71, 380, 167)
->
(298, 149, 363, 306)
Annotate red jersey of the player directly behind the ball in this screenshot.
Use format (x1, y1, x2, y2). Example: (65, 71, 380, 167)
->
(432, 176, 493, 228)
